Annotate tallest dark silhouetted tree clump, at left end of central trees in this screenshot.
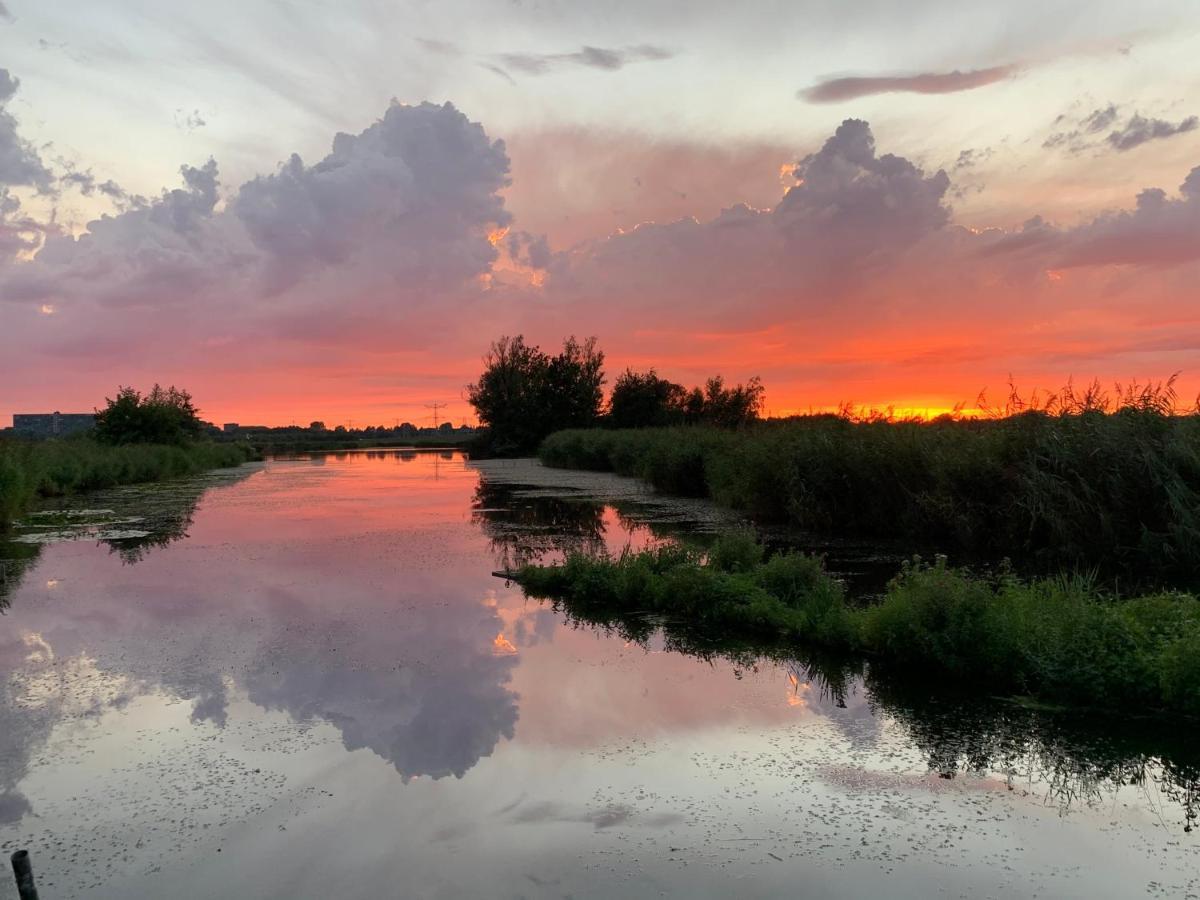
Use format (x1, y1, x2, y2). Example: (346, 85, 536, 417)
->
(467, 335, 604, 455)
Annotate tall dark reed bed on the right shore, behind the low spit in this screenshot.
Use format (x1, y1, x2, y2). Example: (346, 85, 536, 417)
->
(540, 408, 1200, 577)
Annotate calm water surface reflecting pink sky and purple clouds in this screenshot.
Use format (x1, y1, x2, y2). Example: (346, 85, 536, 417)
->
(0, 451, 1200, 900)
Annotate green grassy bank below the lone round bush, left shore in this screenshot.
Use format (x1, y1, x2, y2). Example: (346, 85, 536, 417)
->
(0, 439, 253, 528)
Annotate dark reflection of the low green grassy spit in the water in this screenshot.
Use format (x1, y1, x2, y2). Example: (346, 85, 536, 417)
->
(540, 556, 1200, 832)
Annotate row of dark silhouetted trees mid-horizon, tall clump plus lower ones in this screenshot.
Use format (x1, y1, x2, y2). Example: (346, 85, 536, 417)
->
(467, 335, 764, 455)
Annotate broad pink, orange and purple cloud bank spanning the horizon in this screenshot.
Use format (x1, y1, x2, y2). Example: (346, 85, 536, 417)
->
(0, 96, 1200, 424)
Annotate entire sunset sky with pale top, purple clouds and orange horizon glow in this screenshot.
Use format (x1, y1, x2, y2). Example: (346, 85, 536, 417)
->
(0, 0, 1200, 426)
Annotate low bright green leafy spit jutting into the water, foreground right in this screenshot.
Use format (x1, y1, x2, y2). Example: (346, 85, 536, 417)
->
(516, 534, 1200, 715)
